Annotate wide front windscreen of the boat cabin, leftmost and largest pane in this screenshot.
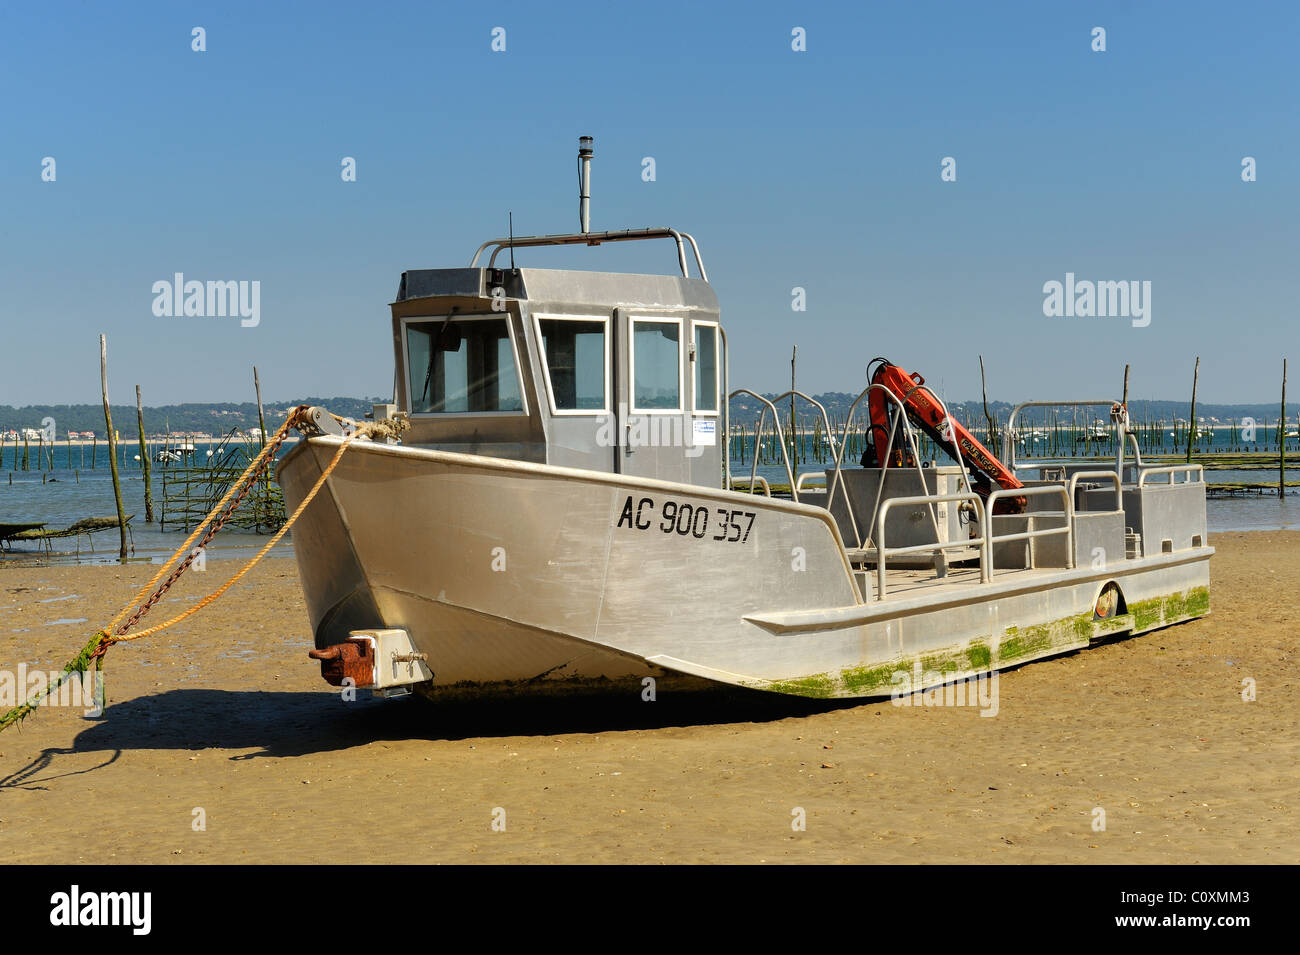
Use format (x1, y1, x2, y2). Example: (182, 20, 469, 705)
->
(406, 316, 525, 414)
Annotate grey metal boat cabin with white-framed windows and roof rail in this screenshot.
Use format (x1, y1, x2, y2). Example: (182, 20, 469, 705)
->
(391, 229, 727, 487)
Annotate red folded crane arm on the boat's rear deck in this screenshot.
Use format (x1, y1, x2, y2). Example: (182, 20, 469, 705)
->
(862, 359, 1026, 515)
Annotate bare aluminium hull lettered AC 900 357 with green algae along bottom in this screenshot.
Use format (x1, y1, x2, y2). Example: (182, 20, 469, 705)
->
(278, 437, 1213, 696)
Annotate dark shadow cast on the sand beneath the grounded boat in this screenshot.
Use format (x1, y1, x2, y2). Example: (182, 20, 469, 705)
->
(0, 689, 863, 790)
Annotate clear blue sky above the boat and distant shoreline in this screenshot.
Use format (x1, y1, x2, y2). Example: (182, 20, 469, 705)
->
(0, 0, 1300, 404)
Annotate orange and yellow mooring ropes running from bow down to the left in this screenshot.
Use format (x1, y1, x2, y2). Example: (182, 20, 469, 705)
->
(0, 404, 403, 732)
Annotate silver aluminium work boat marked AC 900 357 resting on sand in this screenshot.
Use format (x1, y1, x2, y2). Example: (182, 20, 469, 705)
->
(277, 140, 1214, 699)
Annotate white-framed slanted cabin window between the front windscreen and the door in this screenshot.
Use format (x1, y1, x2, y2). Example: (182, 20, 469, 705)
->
(537, 316, 610, 414)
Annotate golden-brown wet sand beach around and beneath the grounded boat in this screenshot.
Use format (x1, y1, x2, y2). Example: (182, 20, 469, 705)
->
(0, 531, 1300, 864)
